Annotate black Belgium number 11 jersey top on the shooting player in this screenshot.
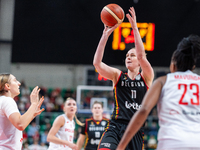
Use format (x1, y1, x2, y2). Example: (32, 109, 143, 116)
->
(111, 72, 148, 123)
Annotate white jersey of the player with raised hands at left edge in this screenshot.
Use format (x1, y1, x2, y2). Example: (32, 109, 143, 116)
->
(0, 96, 23, 150)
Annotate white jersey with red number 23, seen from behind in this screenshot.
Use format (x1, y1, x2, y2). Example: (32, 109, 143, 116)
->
(157, 70, 200, 150)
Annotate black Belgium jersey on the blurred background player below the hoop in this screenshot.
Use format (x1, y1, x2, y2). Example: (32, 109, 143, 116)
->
(81, 117, 108, 150)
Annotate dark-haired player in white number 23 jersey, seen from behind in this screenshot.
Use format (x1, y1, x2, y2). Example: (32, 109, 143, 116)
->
(117, 35, 200, 150)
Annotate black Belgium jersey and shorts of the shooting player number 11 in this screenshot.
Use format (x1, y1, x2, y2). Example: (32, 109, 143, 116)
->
(98, 72, 148, 150)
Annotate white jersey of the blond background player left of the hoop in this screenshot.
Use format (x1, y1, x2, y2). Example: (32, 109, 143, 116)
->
(48, 114, 75, 150)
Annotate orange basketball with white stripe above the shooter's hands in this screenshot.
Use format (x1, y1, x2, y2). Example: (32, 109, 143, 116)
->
(101, 4, 124, 27)
